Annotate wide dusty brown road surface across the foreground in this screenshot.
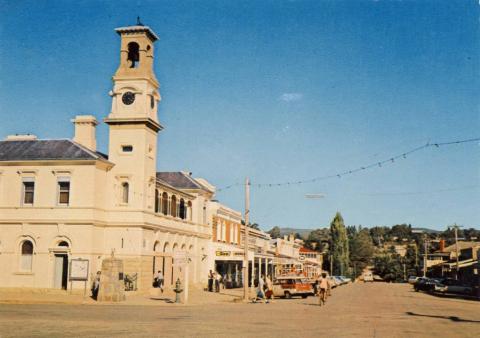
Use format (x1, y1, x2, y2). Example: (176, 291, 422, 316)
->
(0, 283, 480, 338)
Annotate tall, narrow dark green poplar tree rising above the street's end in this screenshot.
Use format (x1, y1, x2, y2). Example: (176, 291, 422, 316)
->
(330, 212, 349, 275)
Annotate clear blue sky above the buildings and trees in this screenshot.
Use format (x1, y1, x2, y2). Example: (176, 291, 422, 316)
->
(0, 0, 480, 229)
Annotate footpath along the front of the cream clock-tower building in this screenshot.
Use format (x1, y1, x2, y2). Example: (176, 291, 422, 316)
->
(0, 287, 249, 306)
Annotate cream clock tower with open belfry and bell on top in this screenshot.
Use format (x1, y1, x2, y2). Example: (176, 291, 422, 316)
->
(105, 23, 163, 210)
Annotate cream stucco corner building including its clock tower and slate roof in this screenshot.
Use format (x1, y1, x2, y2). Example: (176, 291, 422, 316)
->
(0, 26, 214, 290)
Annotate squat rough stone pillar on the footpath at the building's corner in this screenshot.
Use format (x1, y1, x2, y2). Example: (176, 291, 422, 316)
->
(98, 253, 125, 302)
